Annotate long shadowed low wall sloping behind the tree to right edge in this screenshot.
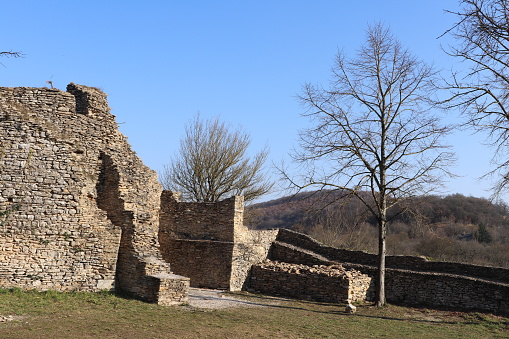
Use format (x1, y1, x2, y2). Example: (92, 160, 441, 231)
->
(270, 229, 509, 315)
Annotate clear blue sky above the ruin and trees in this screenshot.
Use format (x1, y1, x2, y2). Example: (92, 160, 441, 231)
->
(0, 0, 500, 202)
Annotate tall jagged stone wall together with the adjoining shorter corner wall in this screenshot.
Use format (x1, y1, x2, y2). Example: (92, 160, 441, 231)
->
(0, 83, 294, 305)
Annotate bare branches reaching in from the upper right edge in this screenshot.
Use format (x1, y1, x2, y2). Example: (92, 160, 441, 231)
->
(442, 0, 509, 196)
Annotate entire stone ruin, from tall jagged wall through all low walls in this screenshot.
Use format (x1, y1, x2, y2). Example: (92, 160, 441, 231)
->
(0, 83, 509, 314)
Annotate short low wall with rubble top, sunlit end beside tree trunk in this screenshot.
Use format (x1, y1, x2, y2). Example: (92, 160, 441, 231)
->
(250, 260, 373, 303)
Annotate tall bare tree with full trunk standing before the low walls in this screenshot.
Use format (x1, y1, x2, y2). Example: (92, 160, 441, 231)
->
(282, 24, 453, 306)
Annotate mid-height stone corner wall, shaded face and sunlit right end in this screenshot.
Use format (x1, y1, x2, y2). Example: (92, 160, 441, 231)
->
(159, 191, 277, 291)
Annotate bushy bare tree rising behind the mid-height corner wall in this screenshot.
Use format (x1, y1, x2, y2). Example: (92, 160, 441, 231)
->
(161, 115, 273, 202)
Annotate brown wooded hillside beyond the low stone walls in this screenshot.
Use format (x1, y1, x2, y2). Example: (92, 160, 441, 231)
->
(246, 192, 509, 267)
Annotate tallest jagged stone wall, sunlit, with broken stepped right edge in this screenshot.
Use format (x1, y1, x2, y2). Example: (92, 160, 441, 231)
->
(0, 84, 189, 303)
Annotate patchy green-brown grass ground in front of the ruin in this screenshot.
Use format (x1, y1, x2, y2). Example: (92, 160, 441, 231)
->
(0, 290, 509, 339)
